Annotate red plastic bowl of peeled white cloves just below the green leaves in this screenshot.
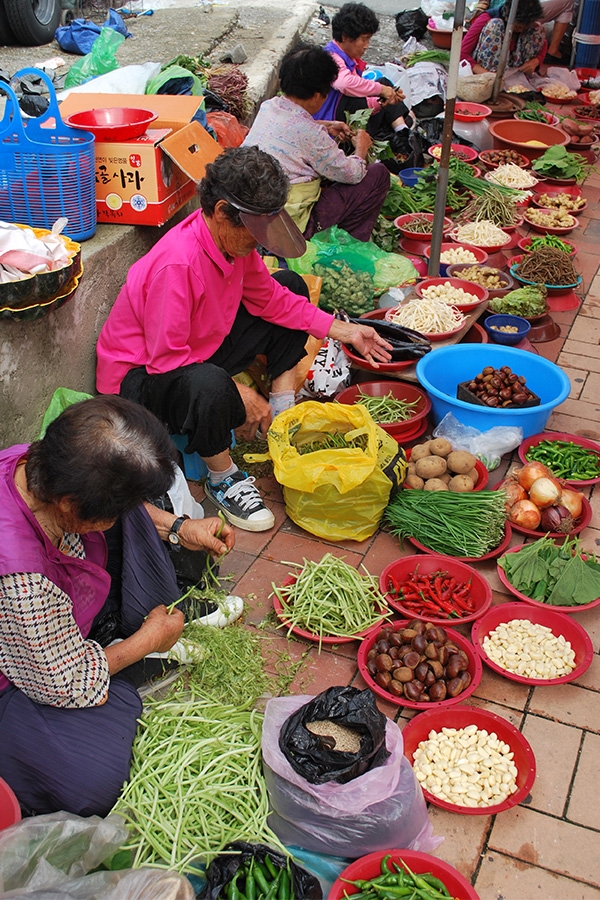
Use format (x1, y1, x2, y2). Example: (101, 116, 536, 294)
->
(471, 603, 594, 686)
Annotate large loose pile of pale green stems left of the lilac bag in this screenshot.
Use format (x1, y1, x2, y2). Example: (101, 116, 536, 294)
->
(113, 693, 286, 873)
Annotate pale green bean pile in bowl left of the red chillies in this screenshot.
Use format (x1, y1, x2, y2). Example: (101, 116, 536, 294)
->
(272, 556, 390, 649)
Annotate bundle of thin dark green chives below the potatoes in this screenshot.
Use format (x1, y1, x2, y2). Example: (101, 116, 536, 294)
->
(385, 491, 506, 558)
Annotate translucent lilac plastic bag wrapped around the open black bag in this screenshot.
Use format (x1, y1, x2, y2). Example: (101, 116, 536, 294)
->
(262, 696, 443, 858)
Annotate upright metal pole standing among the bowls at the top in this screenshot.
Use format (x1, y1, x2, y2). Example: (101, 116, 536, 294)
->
(427, 0, 465, 278)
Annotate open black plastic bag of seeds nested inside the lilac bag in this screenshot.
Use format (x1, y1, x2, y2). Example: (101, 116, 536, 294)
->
(279, 687, 389, 784)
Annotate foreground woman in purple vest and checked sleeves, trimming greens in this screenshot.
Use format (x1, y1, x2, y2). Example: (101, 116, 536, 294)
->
(0, 396, 233, 816)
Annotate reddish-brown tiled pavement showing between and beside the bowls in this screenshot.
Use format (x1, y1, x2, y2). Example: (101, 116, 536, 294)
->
(193, 175, 600, 900)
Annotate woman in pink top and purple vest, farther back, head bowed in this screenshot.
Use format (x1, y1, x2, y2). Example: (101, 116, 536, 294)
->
(313, 3, 410, 138)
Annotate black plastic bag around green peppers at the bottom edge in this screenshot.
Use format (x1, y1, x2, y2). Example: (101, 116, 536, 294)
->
(197, 841, 323, 900)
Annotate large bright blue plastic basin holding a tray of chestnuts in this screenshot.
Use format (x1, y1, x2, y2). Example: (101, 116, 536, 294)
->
(416, 344, 571, 437)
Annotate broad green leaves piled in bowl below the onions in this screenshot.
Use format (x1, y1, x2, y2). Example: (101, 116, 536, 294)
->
(498, 536, 600, 606)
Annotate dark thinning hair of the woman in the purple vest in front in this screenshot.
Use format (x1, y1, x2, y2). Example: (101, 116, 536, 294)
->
(25, 396, 177, 522)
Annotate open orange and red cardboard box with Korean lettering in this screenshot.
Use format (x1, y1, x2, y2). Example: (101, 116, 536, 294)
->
(60, 93, 222, 225)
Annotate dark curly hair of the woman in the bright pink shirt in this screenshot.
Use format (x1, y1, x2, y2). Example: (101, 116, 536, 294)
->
(198, 147, 290, 225)
